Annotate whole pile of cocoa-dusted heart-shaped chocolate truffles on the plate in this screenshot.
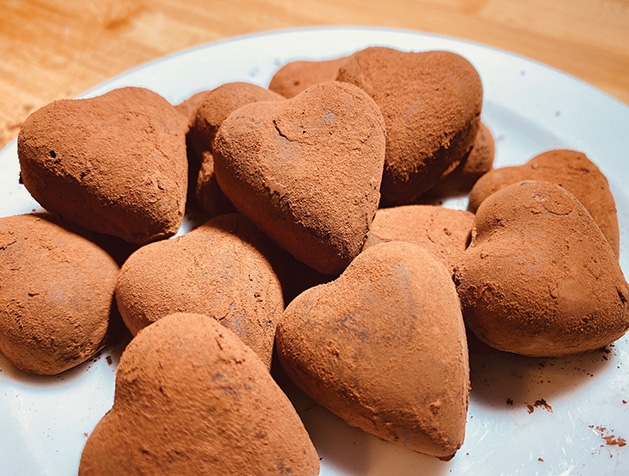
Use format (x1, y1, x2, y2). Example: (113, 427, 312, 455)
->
(0, 43, 629, 475)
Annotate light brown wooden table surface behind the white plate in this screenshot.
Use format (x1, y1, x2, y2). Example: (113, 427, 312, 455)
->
(0, 0, 629, 147)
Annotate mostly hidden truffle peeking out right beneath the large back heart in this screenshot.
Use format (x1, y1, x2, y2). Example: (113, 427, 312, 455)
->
(420, 122, 496, 199)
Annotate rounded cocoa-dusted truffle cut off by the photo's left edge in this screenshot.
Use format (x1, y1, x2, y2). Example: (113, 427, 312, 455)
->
(0, 214, 118, 375)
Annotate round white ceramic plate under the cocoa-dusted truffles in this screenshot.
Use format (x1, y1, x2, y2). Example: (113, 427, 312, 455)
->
(0, 28, 629, 476)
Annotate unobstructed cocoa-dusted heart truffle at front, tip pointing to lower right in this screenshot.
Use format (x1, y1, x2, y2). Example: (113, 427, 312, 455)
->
(277, 242, 469, 459)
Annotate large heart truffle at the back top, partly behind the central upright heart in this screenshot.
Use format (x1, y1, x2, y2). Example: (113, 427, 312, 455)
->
(337, 47, 483, 205)
